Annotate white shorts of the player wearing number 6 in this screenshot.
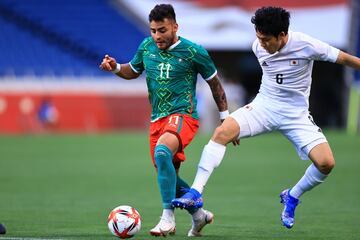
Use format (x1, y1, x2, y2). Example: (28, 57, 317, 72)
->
(230, 94, 327, 160)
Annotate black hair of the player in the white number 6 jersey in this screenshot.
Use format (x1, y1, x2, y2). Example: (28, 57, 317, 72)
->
(251, 7, 290, 37)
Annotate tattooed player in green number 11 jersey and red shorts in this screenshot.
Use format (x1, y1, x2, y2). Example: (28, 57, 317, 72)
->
(100, 4, 233, 236)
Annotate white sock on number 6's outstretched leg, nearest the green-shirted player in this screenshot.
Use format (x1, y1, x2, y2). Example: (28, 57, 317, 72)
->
(191, 140, 226, 193)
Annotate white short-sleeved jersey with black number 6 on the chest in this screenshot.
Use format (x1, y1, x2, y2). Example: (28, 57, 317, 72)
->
(252, 31, 339, 116)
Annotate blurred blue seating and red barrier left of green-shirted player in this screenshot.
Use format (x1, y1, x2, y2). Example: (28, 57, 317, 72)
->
(0, 0, 150, 133)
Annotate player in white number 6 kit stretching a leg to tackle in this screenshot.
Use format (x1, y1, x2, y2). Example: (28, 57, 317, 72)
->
(172, 7, 360, 228)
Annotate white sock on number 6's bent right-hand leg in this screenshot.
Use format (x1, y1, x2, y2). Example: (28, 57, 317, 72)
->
(290, 164, 328, 199)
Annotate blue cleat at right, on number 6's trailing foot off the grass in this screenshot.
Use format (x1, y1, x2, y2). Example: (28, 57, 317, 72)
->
(280, 189, 299, 228)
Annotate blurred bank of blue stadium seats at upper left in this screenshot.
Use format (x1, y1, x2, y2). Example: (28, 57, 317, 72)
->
(0, 0, 145, 76)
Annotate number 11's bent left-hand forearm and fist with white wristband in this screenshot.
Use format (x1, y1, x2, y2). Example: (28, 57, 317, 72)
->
(99, 55, 140, 80)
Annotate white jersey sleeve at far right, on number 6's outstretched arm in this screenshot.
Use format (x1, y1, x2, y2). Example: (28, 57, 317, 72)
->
(304, 36, 340, 63)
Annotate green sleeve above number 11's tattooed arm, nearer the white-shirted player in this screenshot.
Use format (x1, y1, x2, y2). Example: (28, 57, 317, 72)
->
(194, 47, 217, 81)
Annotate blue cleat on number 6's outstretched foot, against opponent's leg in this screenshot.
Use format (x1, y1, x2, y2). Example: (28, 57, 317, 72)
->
(171, 188, 203, 209)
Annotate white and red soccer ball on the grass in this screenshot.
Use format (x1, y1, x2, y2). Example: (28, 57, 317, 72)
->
(108, 205, 141, 239)
